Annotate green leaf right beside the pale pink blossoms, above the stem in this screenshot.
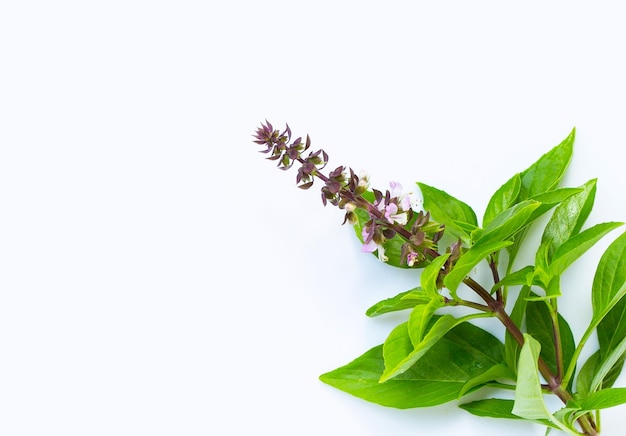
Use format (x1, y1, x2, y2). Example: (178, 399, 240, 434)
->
(417, 183, 478, 239)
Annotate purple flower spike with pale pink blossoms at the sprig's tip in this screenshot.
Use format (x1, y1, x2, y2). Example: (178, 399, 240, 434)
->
(254, 121, 444, 267)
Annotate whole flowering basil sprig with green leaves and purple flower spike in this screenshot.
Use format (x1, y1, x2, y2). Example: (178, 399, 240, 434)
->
(254, 121, 626, 435)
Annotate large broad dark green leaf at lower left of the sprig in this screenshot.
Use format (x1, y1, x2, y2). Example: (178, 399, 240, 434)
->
(320, 323, 503, 409)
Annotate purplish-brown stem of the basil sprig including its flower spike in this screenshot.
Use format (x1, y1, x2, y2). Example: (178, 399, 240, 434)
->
(254, 122, 601, 436)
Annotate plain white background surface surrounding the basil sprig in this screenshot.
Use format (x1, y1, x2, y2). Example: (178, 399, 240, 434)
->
(0, 0, 626, 436)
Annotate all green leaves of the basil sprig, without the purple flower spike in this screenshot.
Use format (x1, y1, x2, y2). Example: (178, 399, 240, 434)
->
(321, 131, 626, 434)
